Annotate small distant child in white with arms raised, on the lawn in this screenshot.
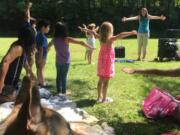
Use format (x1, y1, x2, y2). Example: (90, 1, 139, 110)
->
(83, 23, 99, 64)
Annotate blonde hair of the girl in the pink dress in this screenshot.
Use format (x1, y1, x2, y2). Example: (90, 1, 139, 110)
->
(99, 22, 113, 43)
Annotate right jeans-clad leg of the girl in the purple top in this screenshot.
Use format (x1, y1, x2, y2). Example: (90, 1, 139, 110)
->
(62, 64, 69, 94)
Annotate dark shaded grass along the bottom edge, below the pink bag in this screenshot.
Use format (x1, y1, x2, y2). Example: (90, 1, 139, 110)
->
(109, 118, 180, 135)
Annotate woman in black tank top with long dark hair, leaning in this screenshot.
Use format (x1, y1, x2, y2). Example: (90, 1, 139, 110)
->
(0, 27, 35, 100)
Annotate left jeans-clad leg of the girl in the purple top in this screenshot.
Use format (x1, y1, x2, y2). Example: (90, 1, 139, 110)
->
(56, 63, 62, 92)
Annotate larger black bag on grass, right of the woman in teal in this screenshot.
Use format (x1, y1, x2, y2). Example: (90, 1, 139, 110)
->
(158, 38, 178, 59)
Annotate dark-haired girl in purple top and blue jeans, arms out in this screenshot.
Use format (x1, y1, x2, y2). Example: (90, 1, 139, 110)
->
(48, 22, 93, 96)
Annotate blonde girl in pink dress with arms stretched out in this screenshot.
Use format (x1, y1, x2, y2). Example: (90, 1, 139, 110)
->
(79, 22, 137, 103)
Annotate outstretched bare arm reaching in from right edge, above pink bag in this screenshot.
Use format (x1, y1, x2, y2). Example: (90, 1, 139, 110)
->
(122, 68, 180, 77)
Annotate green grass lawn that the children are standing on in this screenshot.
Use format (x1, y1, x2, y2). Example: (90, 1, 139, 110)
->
(0, 38, 180, 135)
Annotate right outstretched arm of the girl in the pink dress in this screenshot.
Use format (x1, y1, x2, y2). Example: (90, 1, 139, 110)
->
(110, 30, 137, 42)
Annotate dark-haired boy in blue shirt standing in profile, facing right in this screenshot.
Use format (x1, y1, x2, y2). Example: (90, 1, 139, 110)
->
(36, 20, 50, 87)
